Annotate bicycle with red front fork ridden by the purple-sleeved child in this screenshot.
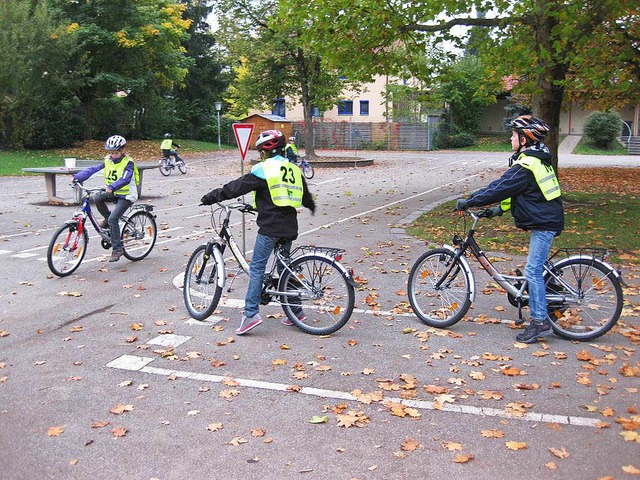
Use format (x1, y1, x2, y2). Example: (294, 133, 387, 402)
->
(47, 183, 158, 277)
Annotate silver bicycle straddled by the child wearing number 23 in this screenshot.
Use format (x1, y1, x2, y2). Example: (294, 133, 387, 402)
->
(183, 203, 359, 335)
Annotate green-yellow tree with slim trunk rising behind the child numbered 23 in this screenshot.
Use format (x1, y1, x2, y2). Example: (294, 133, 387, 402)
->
(218, 0, 355, 157)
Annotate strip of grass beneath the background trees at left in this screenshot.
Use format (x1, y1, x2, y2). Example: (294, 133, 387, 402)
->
(0, 139, 222, 176)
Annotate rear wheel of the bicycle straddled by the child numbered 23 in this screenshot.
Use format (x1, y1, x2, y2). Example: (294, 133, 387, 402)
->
(278, 255, 355, 335)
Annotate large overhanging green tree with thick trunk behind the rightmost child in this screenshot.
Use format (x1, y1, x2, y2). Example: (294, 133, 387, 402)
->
(281, 0, 640, 170)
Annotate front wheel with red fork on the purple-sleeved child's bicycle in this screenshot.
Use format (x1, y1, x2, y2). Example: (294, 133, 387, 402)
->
(47, 222, 89, 277)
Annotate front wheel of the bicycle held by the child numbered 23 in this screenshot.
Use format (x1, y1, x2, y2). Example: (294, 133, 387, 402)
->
(182, 245, 222, 320)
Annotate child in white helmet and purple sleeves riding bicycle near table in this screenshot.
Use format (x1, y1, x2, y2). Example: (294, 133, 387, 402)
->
(73, 135, 140, 262)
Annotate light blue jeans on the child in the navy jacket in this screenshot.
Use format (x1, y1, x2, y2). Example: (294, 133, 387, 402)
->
(524, 230, 556, 322)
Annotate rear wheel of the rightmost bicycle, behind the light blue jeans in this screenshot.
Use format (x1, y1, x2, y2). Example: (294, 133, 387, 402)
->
(545, 257, 623, 342)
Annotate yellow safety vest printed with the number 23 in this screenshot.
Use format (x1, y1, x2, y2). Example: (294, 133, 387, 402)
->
(262, 158, 304, 207)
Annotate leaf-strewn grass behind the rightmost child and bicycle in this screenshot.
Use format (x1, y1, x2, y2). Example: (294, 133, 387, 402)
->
(407, 191, 640, 265)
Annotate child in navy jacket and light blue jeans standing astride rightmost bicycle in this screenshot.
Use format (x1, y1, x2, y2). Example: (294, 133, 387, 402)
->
(457, 115, 564, 343)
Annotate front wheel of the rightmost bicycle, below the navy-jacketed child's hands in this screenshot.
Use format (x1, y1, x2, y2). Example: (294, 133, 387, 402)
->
(407, 248, 473, 328)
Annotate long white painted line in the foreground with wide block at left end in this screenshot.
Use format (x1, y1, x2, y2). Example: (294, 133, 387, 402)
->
(106, 355, 600, 428)
